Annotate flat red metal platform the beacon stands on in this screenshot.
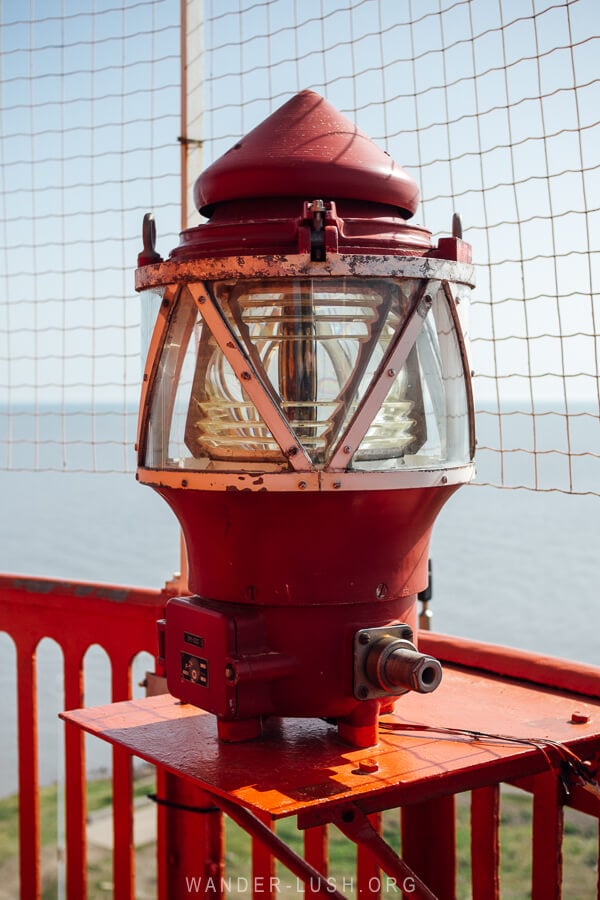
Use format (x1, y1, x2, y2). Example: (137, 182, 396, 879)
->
(62, 667, 600, 826)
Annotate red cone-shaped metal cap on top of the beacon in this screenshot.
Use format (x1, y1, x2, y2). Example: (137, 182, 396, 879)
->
(194, 91, 419, 219)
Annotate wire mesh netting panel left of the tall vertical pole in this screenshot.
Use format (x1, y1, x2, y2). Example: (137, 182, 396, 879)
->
(0, 0, 180, 471)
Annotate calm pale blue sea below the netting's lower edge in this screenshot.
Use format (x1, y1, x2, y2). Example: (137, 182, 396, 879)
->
(0, 408, 600, 796)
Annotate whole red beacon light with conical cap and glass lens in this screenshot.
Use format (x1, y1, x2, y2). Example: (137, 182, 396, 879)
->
(136, 91, 474, 747)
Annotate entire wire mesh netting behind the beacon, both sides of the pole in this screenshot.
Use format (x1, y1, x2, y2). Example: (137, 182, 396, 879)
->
(0, 0, 600, 493)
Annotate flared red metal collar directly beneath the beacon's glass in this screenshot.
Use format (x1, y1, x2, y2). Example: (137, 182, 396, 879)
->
(157, 485, 457, 604)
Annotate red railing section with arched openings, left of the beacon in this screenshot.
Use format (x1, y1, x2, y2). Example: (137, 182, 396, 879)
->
(0, 575, 173, 900)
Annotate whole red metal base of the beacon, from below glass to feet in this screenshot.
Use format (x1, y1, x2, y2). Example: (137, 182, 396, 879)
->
(158, 485, 456, 746)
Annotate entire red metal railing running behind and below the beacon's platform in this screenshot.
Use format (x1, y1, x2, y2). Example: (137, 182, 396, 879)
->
(0, 576, 600, 900)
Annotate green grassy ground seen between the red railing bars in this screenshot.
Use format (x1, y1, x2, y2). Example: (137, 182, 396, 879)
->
(0, 774, 598, 900)
